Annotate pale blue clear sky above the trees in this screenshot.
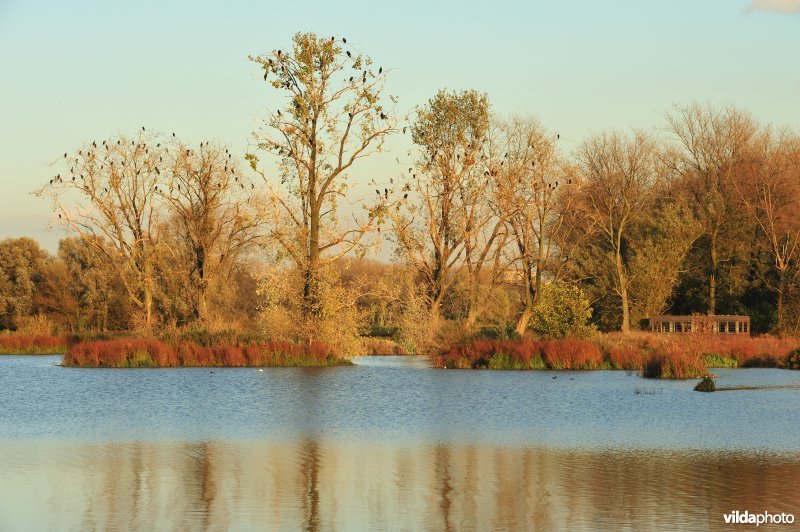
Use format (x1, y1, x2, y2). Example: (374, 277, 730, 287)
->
(0, 0, 800, 251)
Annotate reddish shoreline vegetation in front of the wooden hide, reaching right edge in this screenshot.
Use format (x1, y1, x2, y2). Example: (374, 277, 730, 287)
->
(433, 333, 800, 379)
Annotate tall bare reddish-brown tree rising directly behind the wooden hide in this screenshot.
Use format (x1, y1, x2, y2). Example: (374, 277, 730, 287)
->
(667, 104, 756, 314)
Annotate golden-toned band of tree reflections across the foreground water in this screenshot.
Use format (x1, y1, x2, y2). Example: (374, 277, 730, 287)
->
(0, 437, 800, 530)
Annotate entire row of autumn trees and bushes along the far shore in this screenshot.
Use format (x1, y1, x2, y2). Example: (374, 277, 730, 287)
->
(0, 34, 800, 349)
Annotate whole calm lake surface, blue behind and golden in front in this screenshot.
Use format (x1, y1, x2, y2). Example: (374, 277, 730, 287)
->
(0, 357, 800, 531)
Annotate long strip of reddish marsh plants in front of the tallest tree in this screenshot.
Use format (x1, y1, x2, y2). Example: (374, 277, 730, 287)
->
(64, 338, 349, 368)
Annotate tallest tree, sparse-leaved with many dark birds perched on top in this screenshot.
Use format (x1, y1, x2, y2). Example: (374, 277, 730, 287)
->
(247, 33, 396, 318)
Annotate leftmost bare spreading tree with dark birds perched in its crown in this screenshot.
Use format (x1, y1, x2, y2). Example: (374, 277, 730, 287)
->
(37, 128, 165, 327)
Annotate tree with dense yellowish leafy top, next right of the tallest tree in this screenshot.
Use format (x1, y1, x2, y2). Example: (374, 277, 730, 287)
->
(389, 91, 496, 321)
